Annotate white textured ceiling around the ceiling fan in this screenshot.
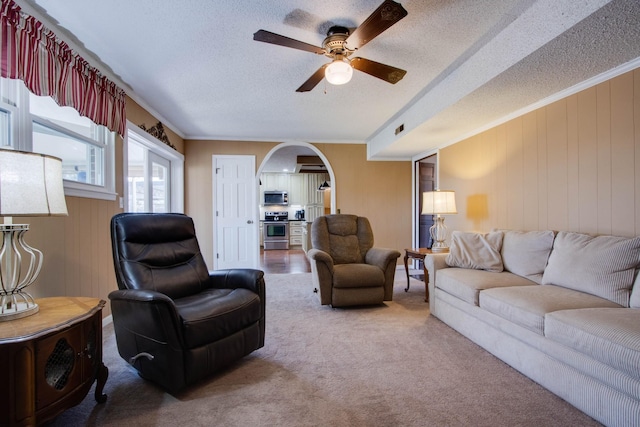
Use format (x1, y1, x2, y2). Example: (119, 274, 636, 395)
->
(17, 0, 640, 167)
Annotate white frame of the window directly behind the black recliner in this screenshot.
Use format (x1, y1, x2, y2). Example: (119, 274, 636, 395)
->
(125, 120, 184, 213)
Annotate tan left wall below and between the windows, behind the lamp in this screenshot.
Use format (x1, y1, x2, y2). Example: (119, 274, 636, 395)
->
(27, 99, 184, 316)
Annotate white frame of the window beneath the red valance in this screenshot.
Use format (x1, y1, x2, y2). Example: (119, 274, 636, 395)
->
(0, 79, 117, 200)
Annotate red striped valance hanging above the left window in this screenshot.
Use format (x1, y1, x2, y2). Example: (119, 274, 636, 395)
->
(0, 0, 126, 136)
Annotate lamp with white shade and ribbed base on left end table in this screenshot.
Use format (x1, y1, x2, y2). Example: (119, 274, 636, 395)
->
(0, 149, 67, 321)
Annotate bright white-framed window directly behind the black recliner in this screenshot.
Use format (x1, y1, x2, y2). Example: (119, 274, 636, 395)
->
(125, 123, 184, 212)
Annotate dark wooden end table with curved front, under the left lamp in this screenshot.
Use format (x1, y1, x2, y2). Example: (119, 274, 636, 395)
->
(0, 297, 109, 426)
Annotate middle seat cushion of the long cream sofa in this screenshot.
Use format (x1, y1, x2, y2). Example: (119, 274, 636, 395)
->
(480, 285, 621, 335)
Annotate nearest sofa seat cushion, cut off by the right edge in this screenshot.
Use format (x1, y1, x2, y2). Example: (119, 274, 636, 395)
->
(544, 308, 640, 378)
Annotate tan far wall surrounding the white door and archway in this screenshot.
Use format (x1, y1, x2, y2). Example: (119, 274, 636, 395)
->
(185, 140, 411, 268)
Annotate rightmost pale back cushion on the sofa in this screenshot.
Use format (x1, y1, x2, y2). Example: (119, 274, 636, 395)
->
(542, 231, 640, 307)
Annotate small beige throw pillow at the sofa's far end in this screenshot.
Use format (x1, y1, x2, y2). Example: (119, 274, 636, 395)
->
(447, 231, 503, 273)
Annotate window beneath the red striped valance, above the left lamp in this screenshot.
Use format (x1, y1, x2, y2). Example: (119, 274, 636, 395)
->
(0, 78, 116, 200)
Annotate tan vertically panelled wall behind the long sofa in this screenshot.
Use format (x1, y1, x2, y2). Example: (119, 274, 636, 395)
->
(439, 69, 640, 236)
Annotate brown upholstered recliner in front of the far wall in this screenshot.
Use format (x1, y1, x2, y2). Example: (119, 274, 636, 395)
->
(307, 214, 400, 307)
